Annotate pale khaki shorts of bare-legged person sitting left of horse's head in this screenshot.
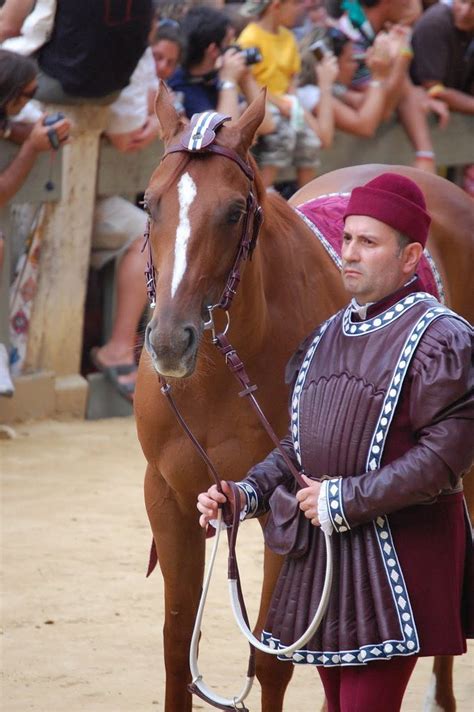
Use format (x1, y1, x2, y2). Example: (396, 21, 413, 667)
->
(90, 195, 147, 269)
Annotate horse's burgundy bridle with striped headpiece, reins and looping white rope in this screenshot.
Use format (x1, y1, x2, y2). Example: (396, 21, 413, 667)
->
(144, 112, 332, 712)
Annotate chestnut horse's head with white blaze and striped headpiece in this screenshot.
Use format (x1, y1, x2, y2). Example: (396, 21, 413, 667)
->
(145, 84, 265, 378)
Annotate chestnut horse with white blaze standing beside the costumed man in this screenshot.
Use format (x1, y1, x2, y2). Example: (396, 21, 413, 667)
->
(135, 89, 474, 712)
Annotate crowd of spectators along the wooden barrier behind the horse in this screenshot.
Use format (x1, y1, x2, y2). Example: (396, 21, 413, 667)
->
(0, 0, 474, 398)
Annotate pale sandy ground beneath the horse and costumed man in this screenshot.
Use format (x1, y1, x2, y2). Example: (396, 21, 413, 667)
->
(0, 419, 474, 712)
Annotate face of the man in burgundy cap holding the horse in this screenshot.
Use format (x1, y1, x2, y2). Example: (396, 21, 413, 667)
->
(342, 215, 410, 304)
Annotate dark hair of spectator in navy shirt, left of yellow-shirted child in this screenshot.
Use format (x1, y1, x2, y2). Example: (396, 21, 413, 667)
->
(181, 5, 230, 69)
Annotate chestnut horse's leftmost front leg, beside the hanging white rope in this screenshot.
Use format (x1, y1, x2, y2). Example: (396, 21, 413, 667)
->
(145, 466, 205, 712)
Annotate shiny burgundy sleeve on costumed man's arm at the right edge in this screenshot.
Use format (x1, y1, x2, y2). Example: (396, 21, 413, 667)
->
(338, 318, 474, 527)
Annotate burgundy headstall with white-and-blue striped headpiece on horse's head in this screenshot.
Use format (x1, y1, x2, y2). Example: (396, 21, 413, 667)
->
(145, 111, 263, 310)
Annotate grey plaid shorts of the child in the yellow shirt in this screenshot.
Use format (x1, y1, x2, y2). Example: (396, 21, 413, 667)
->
(252, 105, 321, 169)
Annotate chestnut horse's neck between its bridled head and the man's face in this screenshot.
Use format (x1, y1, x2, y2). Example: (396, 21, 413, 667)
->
(219, 195, 347, 356)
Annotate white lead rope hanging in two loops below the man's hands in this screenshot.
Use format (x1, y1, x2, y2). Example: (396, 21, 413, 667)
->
(189, 508, 333, 709)
